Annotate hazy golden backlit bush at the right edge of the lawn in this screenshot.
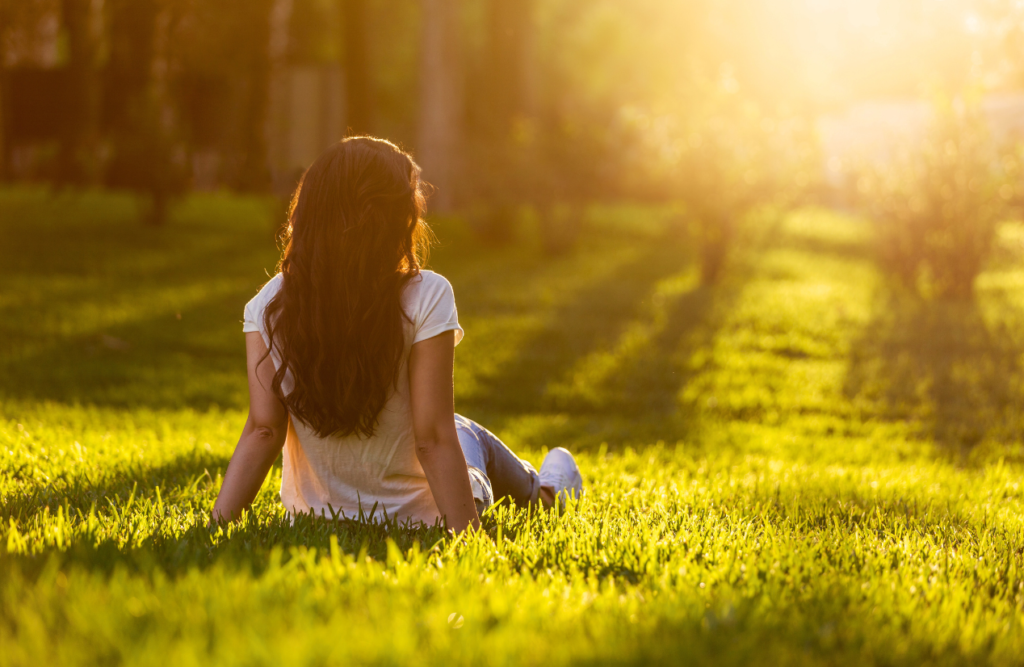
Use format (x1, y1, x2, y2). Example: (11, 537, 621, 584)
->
(857, 100, 1024, 299)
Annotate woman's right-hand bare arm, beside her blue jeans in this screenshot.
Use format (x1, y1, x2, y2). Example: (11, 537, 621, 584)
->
(409, 331, 480, 533)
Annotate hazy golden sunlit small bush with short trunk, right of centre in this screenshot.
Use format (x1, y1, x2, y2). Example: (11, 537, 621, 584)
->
(610, 93, 817, 285)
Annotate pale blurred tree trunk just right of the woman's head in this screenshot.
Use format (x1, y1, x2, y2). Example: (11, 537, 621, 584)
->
(417, 0, 462, 212)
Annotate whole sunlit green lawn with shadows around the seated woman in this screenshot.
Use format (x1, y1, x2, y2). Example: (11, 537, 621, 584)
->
(0, 190, 1024, 665)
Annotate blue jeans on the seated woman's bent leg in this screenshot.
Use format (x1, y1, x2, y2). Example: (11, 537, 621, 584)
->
(455, 414, 541, 507)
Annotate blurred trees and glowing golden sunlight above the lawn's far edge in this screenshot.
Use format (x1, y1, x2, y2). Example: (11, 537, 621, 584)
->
(0, 0, 1024, 238)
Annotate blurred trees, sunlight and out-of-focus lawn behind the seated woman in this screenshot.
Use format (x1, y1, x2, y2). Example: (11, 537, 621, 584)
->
(0, 0, 1024, 460)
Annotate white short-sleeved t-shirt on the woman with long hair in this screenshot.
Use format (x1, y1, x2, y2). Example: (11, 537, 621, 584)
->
(243, 270, 464, 524)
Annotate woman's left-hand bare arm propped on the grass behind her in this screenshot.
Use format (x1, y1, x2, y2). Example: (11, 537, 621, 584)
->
(213, 332, 288, 520)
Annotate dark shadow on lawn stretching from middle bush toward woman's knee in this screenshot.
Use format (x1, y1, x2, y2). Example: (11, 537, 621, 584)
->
(480, 267, 743, 450)
